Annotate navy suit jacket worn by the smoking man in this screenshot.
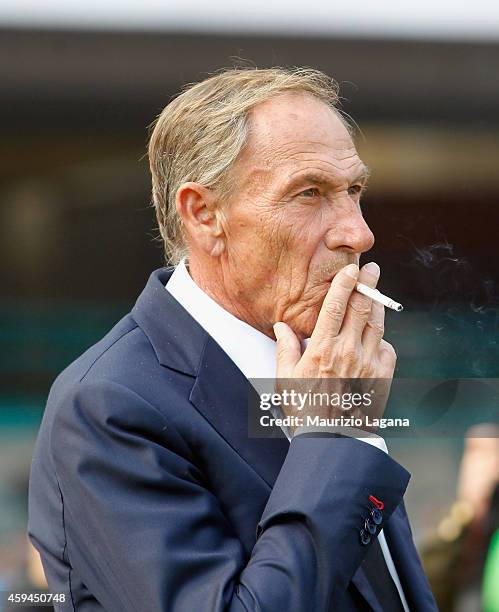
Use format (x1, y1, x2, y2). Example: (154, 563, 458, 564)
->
(29, 268, 436, 612)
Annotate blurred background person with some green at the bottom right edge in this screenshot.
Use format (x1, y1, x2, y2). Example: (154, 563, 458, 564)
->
(421, 424, 499, 612)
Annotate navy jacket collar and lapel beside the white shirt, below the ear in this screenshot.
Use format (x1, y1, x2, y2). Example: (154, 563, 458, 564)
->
(132, 268, 289, 487)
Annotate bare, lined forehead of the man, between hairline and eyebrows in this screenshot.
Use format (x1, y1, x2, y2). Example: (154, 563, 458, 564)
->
(242, 93, 361, 176)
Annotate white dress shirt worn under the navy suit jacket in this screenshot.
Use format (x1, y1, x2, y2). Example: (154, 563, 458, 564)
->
(166, 259, 409, 612)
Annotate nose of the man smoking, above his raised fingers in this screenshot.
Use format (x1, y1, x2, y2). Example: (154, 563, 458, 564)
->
(325, 202, 374, 253)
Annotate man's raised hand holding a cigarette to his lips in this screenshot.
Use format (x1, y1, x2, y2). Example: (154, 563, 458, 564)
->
(274, 263, 396, 436)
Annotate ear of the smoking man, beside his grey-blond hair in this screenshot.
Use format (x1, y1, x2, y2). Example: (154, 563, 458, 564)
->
(175, 182, 225, 257)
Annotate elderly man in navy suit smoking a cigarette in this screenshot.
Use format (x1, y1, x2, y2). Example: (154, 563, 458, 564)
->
(30, 69, 436, 612)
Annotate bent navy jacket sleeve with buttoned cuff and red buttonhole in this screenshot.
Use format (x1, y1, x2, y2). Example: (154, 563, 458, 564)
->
(49, 381, 409, 612)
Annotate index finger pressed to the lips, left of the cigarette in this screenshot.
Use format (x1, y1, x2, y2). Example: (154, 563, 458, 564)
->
(309, 264, 359, 347)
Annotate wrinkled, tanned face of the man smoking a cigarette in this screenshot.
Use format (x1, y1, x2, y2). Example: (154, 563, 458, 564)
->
(217, 94, 374, 338)
